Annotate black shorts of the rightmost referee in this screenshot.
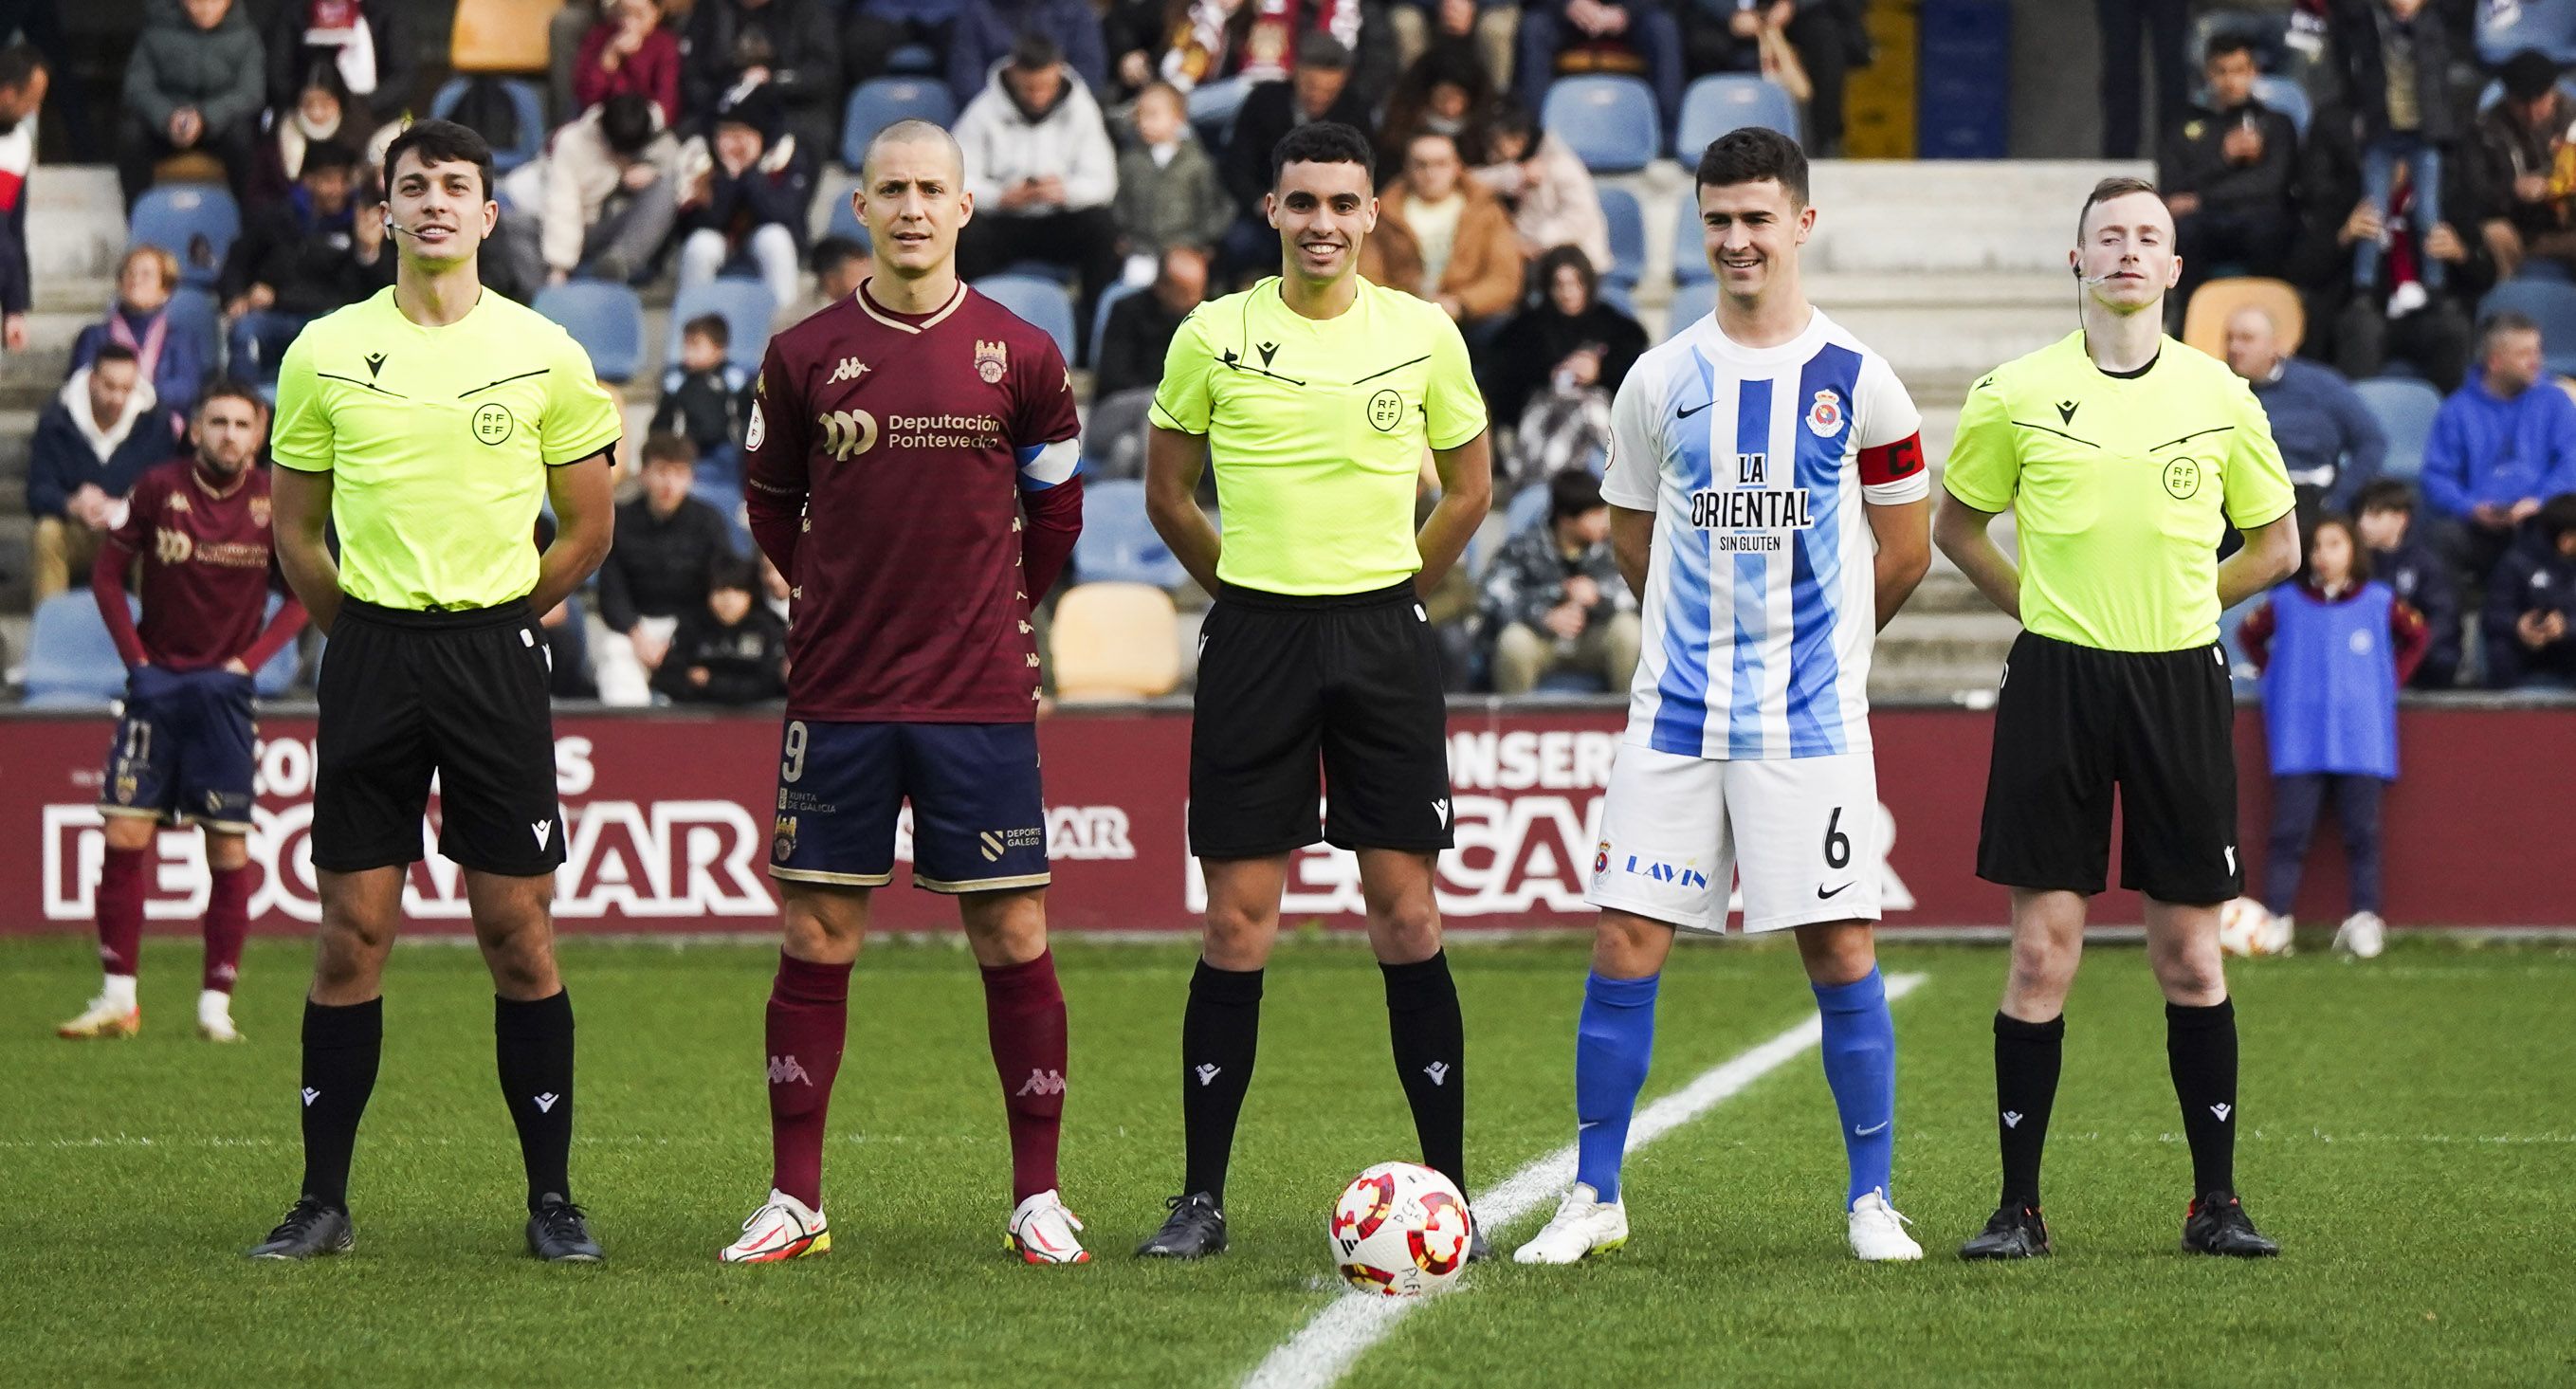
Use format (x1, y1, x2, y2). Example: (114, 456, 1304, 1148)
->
(1976, 631, 2244, 905)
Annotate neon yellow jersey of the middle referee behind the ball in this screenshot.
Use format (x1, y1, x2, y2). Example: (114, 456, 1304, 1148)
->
(1151, 276, 1484, 595)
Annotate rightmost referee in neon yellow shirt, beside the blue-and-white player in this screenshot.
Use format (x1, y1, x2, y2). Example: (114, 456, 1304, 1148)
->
(1932, 178, 2298, 1257)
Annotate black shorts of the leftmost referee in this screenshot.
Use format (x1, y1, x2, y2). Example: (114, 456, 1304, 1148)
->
(312, 598, 564, 879)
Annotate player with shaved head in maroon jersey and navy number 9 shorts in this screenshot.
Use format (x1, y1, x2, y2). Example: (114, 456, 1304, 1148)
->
(716, 121, 1089, 1263)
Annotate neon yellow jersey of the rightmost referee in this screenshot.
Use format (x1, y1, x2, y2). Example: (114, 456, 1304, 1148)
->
(1943, 330, 2293, 652)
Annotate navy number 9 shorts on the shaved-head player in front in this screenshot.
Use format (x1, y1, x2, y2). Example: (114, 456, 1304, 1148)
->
(770, 719, 1049, 891)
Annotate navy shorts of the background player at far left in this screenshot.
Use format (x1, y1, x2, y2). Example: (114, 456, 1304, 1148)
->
(98, 665, 255, 835)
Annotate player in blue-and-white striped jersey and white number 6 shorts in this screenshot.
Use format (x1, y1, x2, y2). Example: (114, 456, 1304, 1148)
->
(1512, 129, 1932, 1263)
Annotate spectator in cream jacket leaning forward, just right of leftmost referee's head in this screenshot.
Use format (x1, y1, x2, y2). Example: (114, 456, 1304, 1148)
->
(495, 93, 683, 297)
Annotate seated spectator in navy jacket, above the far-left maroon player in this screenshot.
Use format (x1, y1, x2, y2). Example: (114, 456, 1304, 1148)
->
(26, 342, 180, 603)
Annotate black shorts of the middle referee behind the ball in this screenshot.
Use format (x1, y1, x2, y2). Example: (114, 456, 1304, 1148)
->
(1190, 582, 1451, 858)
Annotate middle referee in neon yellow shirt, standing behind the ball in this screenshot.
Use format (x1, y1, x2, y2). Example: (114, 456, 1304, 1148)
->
(1136, 121, 1494, 1257)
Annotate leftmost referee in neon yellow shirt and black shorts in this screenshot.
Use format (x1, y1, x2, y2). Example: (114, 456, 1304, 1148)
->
(250, 121, 621, 1263)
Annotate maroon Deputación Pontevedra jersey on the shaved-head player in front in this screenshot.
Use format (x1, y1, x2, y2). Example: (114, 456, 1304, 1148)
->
(741, 286, 1079, 724)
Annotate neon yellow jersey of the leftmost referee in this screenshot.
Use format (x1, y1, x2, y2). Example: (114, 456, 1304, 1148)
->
(270, 288, 624, 611)
